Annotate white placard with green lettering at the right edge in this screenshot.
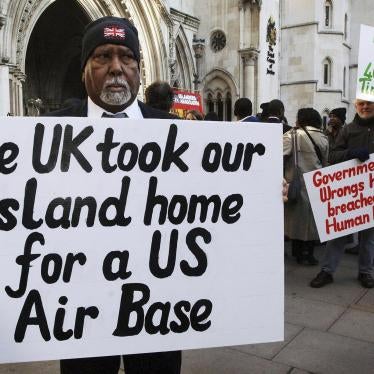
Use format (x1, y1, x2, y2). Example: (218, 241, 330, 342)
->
(356, 25, 374, 101)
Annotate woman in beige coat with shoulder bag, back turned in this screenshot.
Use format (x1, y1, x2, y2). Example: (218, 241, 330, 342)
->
(283, 108, 329, 265)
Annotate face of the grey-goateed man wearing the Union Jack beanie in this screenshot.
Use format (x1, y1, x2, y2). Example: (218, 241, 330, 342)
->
(83, 44, 140, 113)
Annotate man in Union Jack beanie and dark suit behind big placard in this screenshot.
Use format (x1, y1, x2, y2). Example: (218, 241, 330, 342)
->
(43, 17, 181, 374)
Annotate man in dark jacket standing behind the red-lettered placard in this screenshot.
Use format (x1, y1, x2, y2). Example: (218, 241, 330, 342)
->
(310, 99, 374, 288)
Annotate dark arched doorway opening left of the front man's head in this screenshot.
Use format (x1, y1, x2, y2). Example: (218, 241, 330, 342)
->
(24, 0, 90, 115)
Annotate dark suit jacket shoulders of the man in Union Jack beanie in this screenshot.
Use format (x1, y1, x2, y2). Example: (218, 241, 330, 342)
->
(44, 100, 180, 119)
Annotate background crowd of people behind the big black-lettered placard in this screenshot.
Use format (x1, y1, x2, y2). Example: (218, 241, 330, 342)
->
(146, 82, 374, 288)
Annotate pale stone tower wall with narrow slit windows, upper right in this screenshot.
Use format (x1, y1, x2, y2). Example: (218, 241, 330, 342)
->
(280, 0, 351, 125)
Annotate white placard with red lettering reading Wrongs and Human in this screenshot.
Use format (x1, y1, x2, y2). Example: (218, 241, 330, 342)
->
(304, 154, 374, 242)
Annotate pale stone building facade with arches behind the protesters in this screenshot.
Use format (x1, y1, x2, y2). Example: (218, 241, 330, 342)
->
(0, 0, 374, 123)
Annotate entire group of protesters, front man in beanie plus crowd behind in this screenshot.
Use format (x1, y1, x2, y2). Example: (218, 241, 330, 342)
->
(36, 13, 374, 374)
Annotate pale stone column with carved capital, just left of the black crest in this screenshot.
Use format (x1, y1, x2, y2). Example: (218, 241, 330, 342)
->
(240, 48, 259, 111)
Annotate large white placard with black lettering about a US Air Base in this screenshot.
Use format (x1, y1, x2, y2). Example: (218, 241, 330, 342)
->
(0, 118, 284, 362)
